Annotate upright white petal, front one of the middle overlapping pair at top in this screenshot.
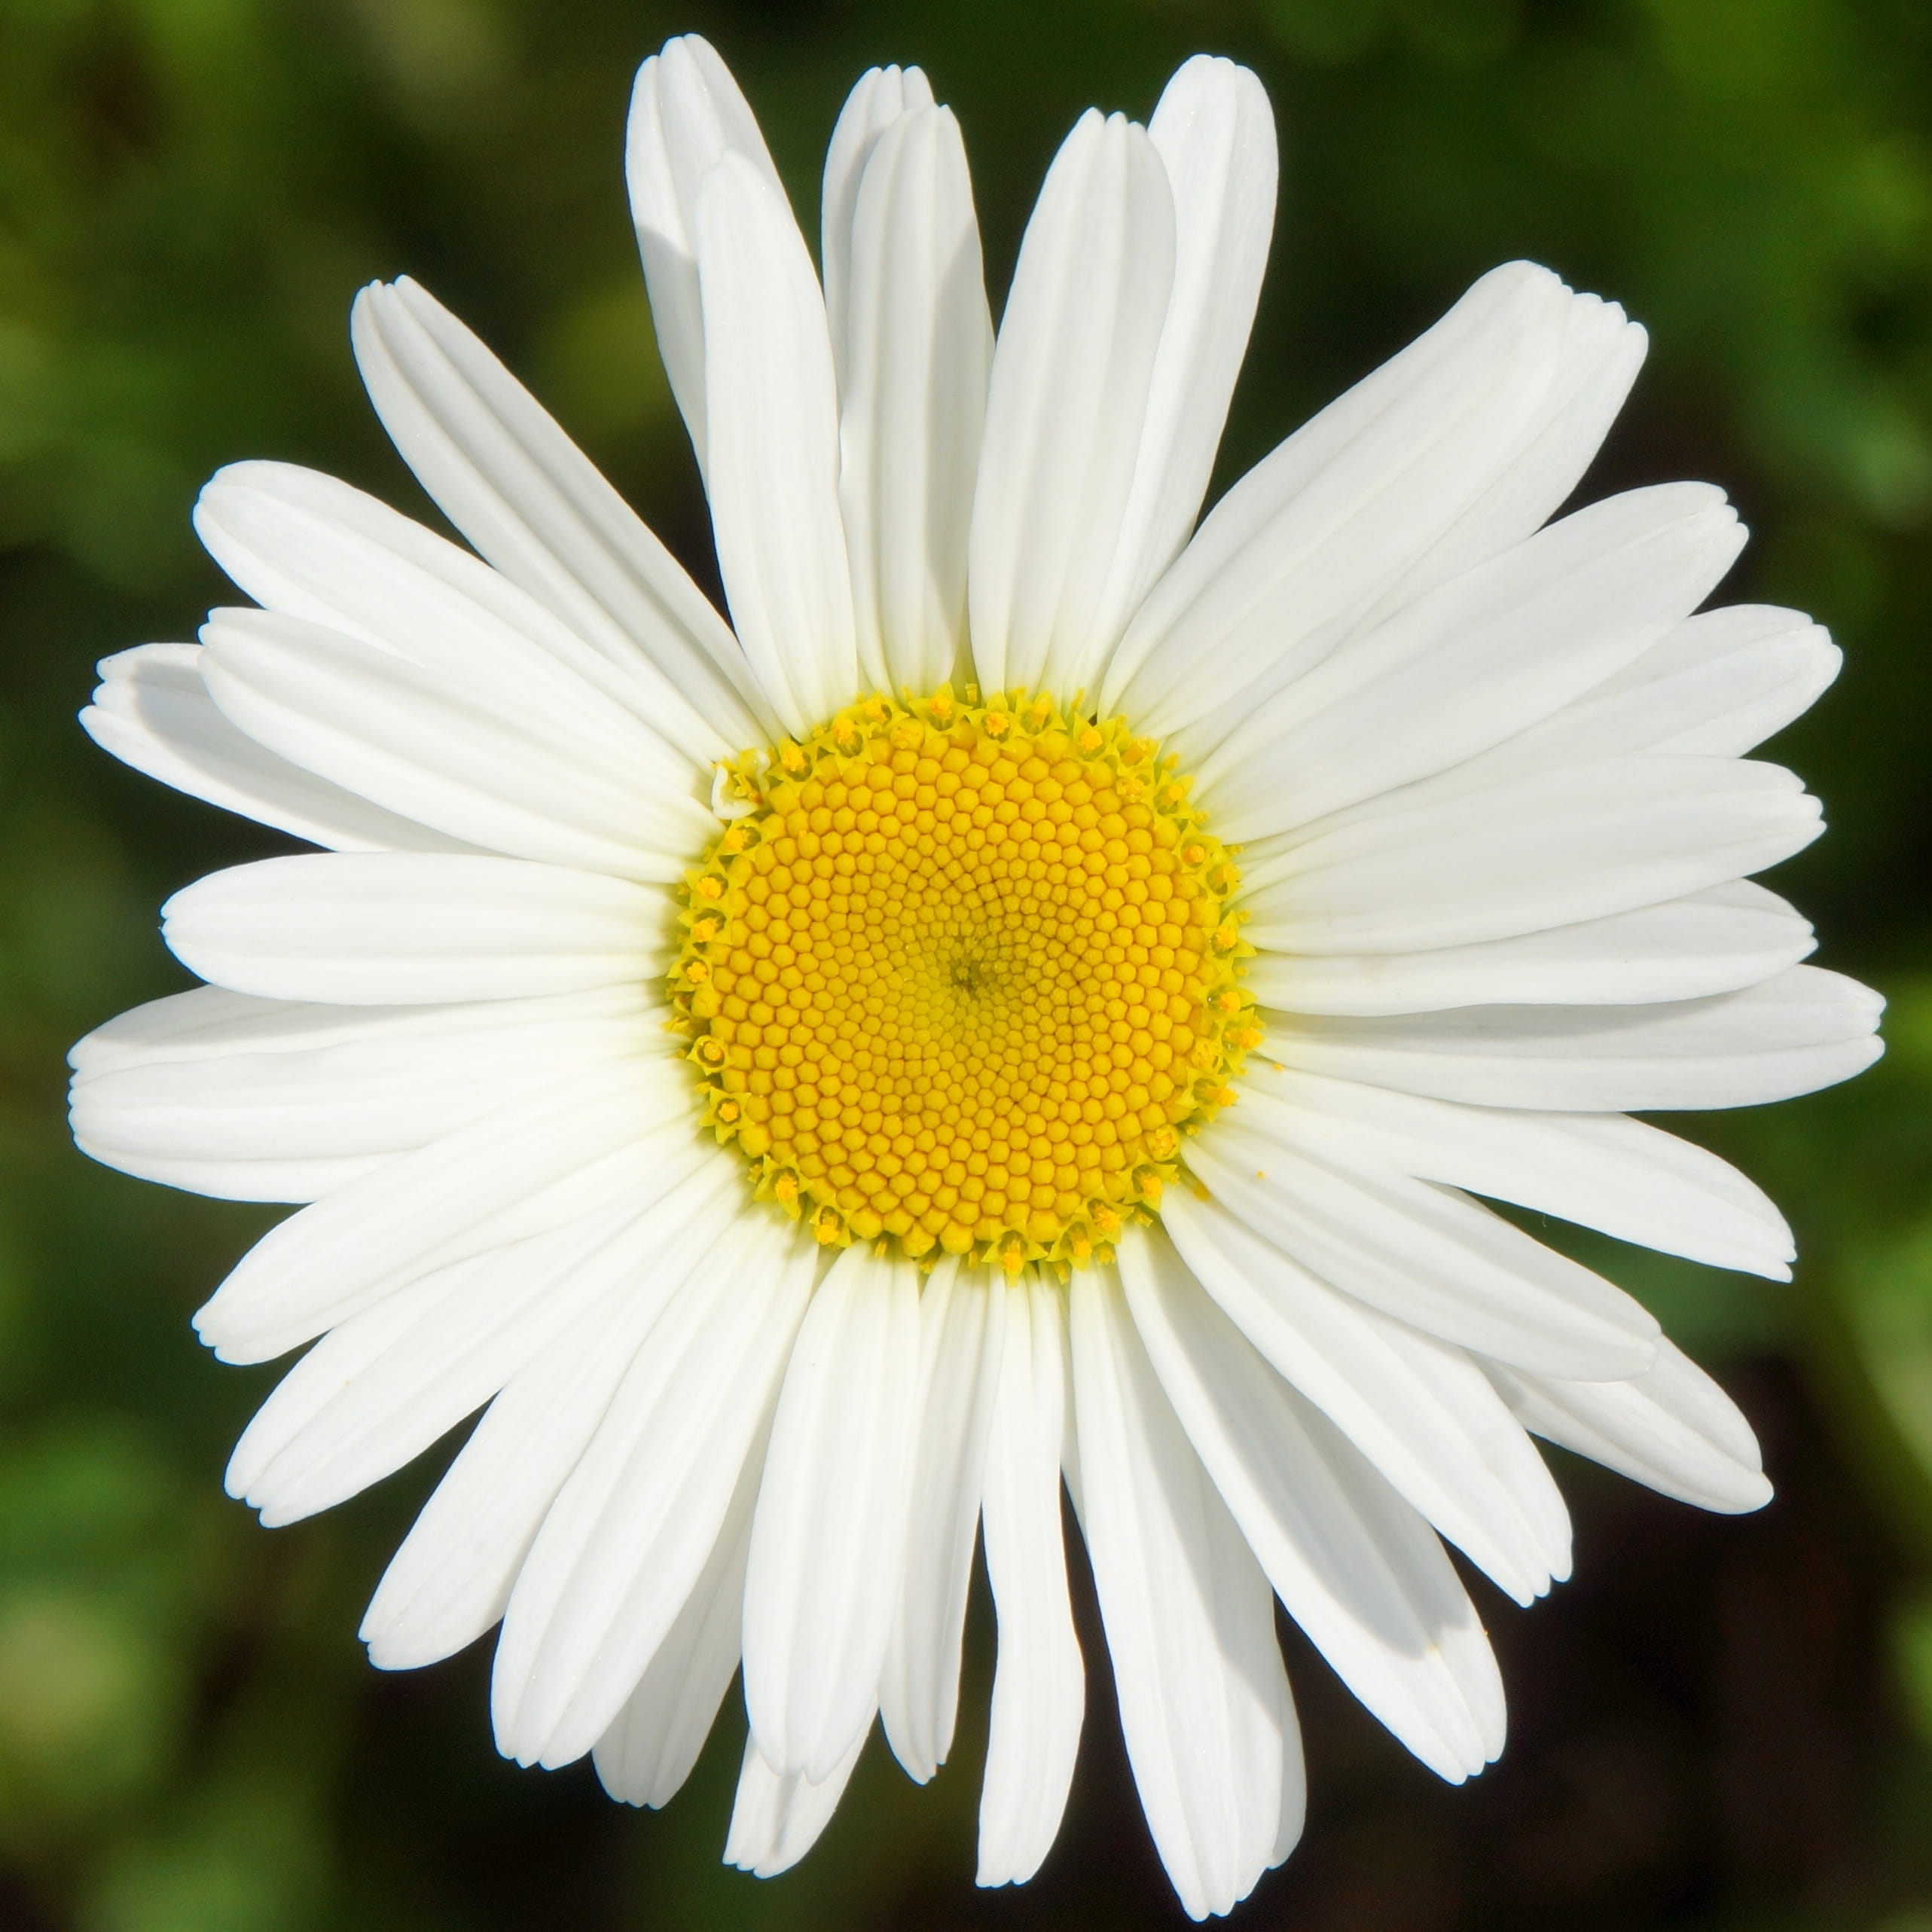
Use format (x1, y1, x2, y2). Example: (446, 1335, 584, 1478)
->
(825, 102, 993, 691)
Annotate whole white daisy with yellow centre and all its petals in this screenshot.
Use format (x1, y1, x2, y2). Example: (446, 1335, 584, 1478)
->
(73, 38, 1878, 1916)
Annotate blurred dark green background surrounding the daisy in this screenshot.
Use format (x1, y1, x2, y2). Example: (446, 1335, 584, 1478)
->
(0, 0, 1932, 1932)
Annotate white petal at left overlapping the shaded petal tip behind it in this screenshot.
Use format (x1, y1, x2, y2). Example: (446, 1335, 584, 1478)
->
(201, 611, 717, 885)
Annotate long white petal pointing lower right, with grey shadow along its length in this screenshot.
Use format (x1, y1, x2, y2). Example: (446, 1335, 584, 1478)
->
(1105, 1244, 1503, 1783)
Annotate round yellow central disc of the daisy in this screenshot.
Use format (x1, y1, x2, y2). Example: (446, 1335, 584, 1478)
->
(670, 688, 1259, 1271)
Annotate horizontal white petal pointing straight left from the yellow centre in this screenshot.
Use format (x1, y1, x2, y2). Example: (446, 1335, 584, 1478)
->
(162, 852, 674, 1006)
